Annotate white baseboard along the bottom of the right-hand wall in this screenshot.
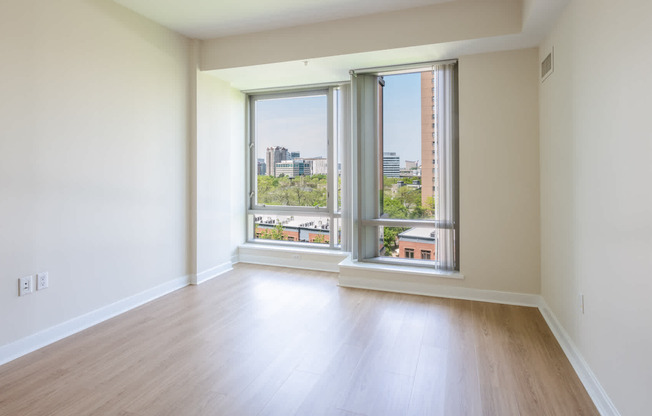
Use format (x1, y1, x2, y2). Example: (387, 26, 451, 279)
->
(539, 297, 620, 416)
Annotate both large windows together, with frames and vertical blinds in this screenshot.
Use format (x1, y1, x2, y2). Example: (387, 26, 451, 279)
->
(248, 62, 460, 270)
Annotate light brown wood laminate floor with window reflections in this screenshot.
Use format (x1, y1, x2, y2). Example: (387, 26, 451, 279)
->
(0, 265, 598, 416)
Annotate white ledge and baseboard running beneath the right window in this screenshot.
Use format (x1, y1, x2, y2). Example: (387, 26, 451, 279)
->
(339, 259, 540, 307)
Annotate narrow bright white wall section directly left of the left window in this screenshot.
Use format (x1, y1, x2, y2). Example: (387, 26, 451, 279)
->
(195, 71, 245, 280)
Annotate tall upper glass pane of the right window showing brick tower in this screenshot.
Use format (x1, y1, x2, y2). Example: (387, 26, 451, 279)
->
(380, 71, 436, 221)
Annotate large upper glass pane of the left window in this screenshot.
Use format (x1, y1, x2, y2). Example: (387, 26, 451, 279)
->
(254, 95, 328, 207)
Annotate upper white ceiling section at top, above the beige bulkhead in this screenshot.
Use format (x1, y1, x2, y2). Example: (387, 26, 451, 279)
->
(114, 0, 454, 39)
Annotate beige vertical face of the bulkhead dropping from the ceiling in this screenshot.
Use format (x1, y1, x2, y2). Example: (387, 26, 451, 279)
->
(201, 0, 522, 70)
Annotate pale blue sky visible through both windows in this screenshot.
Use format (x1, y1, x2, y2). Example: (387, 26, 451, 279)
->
(256, 73, 421, 167)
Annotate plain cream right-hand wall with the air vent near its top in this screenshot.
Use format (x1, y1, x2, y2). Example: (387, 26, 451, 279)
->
(540, 0, 652, 415)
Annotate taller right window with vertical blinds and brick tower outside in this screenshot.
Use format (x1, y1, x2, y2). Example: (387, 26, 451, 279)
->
(353, 63, 459, 270)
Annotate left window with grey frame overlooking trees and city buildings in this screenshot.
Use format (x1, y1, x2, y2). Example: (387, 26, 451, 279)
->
(248, 87, 341, 248)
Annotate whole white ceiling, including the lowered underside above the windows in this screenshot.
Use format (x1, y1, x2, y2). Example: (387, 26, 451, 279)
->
(114, 0, 570, 90)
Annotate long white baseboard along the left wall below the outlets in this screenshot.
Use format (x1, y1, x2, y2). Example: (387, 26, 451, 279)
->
(0, 276, 190, 365)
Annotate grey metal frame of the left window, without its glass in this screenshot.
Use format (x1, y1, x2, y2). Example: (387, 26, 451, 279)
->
(245, 84, 343, 250)
